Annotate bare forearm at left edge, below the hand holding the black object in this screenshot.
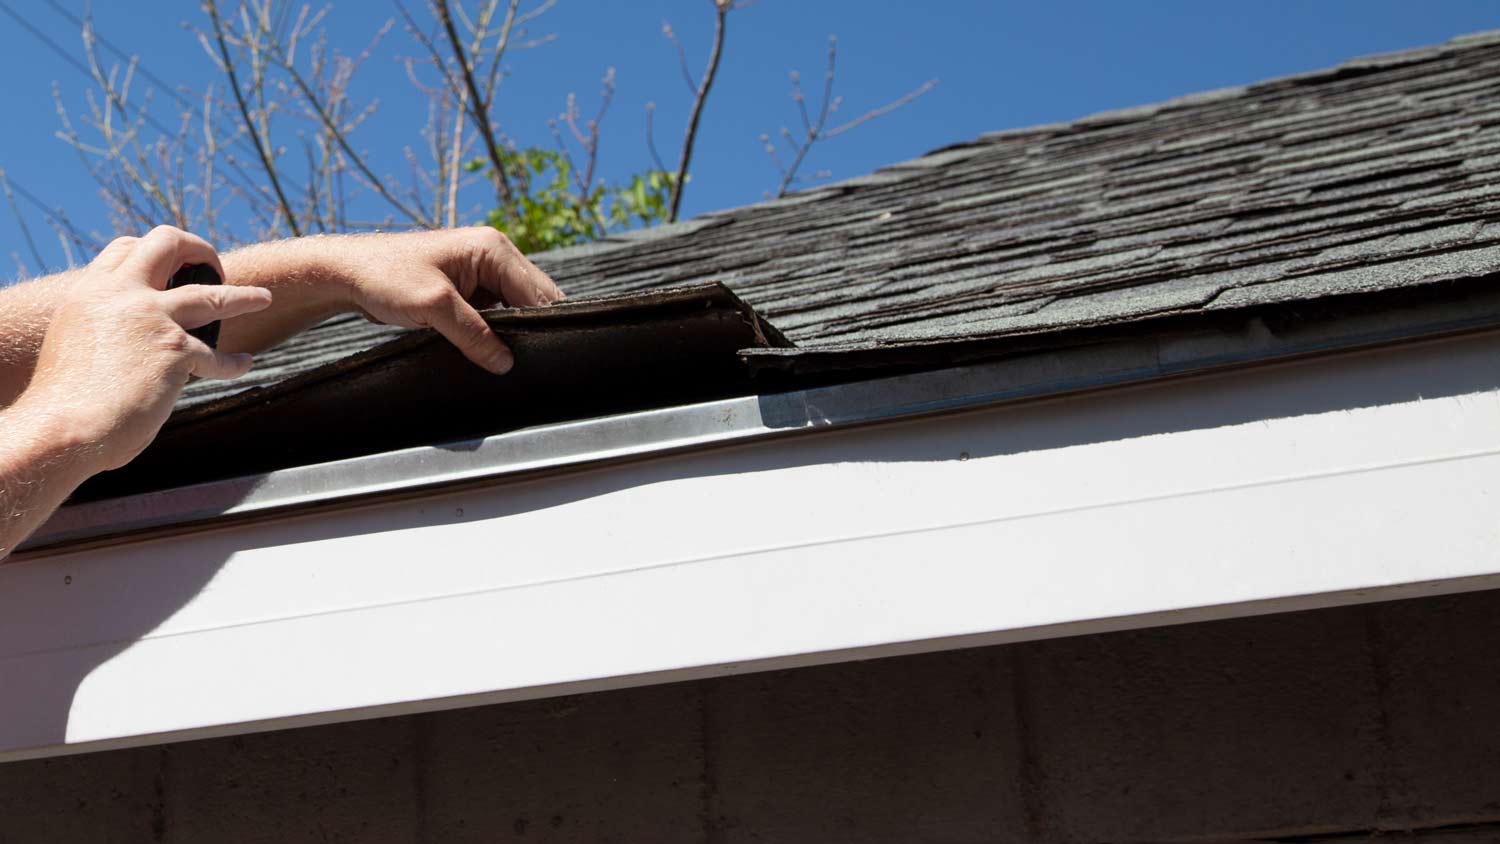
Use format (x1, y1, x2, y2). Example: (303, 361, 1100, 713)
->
(0, 396, 98, 561)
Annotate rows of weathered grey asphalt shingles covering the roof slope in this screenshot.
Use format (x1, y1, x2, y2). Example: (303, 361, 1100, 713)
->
(185, 33, 1500, 403)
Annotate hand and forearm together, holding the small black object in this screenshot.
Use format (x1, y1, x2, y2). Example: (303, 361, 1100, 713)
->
(0, 226, 272, 558)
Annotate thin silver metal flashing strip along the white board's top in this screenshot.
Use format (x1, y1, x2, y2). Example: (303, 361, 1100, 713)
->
(18, 289, 1500, 553)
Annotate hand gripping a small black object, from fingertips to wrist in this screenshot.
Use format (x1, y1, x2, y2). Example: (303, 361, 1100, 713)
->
(18, 226, 272, 472)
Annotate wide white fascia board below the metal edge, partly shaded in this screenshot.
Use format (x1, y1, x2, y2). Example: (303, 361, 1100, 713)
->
(0, 328, 1500, 760)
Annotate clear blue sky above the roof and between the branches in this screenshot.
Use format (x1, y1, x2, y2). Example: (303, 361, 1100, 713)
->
(0, 0, 1500, 277)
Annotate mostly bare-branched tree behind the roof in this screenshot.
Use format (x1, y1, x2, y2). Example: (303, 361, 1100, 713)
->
(0, 0, 935, 273)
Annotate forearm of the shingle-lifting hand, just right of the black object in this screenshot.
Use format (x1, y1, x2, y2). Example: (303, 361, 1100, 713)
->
(219, 237, 353, 354)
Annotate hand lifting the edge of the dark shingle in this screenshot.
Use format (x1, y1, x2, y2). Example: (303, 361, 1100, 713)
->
(328, 226, 563, 373)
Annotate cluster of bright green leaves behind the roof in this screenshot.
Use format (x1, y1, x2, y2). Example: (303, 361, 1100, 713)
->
(465, 147, 674, 253)
